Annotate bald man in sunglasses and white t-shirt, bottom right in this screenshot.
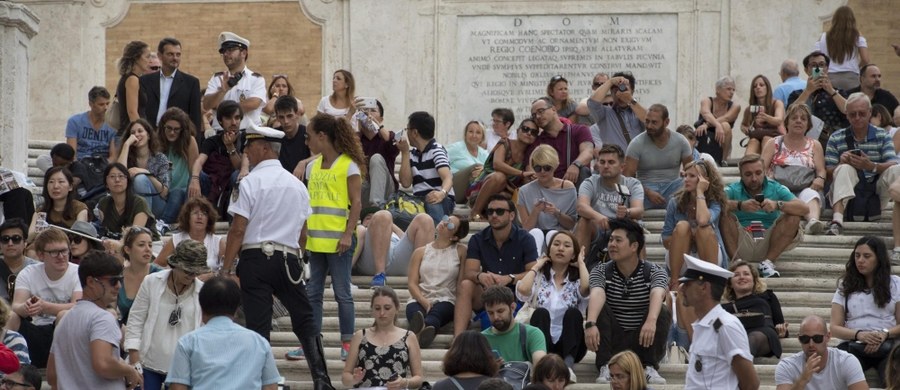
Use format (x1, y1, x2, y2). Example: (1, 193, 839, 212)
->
(775, 316, 869, 390)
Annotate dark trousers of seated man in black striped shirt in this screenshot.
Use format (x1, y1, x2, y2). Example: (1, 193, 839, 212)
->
(596, 302, 672, 370)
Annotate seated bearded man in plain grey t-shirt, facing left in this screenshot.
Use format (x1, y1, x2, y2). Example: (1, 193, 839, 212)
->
(624, 104, 694, 209)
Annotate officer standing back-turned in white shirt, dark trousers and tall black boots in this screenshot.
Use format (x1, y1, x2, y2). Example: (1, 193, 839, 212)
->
(223, 125, 334, 390)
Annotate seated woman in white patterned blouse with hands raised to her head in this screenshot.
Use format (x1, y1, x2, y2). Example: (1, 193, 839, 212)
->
(516, 231, 590, 369)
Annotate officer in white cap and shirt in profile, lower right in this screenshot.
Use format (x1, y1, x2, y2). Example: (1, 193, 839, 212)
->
(679, 255, 759, 390)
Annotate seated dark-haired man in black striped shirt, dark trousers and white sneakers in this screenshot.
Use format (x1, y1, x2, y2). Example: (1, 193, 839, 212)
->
(584, 219, 672, 385)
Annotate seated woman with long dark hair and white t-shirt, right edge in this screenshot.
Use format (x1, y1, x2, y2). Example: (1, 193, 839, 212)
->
(831, 236, 900, 387)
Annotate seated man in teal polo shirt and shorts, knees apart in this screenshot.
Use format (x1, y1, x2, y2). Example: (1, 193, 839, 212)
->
(719, 154, 809, 278)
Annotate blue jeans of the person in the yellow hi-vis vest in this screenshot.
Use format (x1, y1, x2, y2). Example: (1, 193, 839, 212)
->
(306, 235, 356, 341)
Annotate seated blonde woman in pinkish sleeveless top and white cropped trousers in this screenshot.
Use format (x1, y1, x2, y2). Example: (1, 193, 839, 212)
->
(762, 104, 828, 235)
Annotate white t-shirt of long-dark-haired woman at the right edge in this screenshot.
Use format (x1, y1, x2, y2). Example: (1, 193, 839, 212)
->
(831, 275, 900, 330)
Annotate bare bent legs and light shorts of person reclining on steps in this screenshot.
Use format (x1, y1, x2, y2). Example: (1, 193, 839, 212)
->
(353, 208, 435, 286)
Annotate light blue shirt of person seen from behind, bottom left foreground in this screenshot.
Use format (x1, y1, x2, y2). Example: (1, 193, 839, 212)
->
(166, 316, 281, 390)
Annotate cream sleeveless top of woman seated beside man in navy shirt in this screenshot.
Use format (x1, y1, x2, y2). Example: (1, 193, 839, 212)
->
(409, 243, 460, 304)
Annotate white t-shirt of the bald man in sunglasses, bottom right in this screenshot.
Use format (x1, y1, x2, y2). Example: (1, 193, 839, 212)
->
(775, 347, 866, 390)
